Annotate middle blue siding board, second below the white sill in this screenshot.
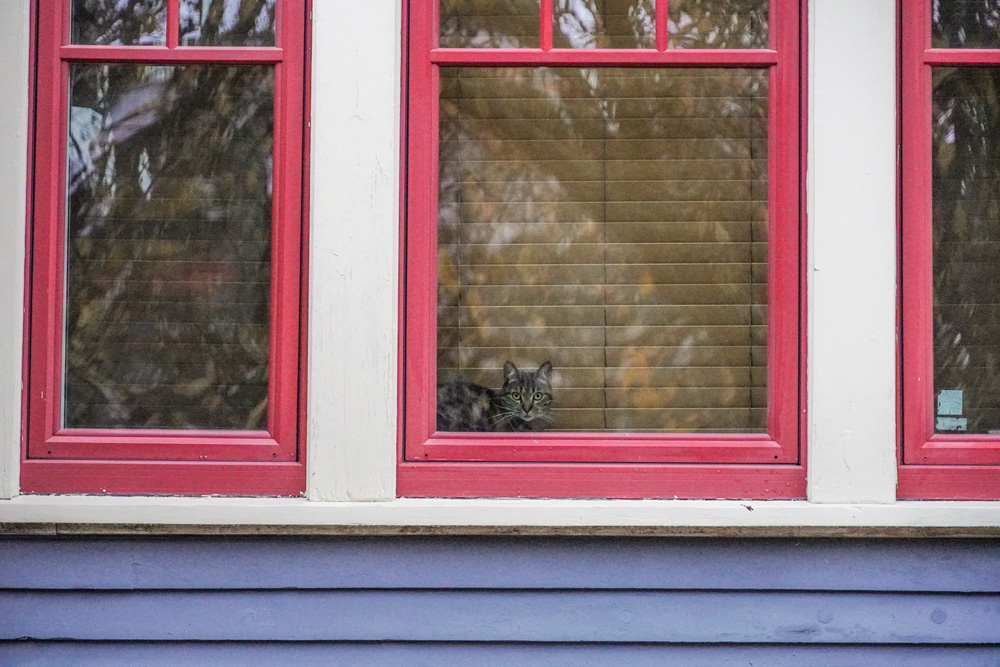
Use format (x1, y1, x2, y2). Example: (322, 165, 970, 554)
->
(0, 590, 1000, 644)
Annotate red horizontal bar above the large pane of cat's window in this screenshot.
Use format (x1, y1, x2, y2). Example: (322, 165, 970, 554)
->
(430, 47, 780, 67)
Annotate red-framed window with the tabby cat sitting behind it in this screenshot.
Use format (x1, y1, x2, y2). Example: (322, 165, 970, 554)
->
(398, 0, 804, 497)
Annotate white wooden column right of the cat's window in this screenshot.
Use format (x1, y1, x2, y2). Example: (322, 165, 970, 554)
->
(806, 0, 896, 503)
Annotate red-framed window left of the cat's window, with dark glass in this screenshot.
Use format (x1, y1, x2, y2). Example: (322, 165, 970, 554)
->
(21, 0, 306, 495)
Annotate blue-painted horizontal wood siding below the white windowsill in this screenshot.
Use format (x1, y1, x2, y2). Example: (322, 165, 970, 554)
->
(0, 537, 1000, 666)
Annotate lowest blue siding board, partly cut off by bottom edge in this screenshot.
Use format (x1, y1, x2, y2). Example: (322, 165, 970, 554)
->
(0, 642, 1000, 667)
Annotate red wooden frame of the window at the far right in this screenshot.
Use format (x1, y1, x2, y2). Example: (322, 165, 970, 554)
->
(897, 2, 1000, 500)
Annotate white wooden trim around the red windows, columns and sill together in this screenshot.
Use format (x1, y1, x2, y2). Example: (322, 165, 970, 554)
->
(0, 0, 1000, 535)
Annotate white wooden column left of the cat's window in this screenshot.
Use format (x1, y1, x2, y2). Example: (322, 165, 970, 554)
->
(307, 0, 401, 500)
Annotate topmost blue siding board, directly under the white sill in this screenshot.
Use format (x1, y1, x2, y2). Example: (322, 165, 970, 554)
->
(0, 538, 1000, 592)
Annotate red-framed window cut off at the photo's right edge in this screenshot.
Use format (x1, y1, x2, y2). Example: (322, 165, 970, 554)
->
(899, 0, 1000, 499)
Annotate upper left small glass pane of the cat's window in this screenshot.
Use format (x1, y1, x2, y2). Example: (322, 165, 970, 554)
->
(441, 0, 541, 49)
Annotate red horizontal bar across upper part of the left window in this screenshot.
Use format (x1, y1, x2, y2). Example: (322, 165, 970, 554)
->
(58, 44, 284, 65)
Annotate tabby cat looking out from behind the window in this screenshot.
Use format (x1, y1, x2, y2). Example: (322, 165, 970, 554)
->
(437, 361, 554, 432)
